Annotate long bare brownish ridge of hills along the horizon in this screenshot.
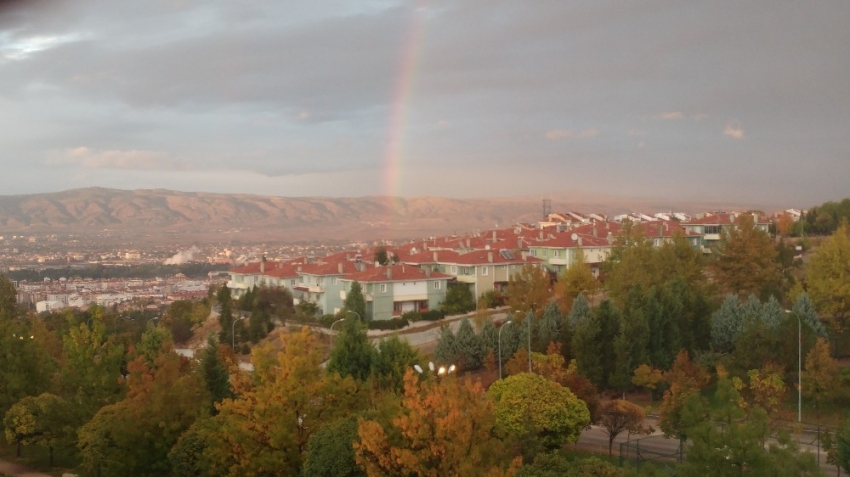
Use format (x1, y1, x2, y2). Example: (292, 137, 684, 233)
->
(0, 188, 776, 242)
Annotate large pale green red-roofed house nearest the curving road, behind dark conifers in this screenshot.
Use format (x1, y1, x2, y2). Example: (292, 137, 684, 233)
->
(340, 264, 452, 321)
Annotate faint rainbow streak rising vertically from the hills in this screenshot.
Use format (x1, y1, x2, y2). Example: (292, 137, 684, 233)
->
(384, 1, 425, 199)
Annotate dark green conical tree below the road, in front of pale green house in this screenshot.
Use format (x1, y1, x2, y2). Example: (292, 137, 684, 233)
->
(328, 317, 375, 381)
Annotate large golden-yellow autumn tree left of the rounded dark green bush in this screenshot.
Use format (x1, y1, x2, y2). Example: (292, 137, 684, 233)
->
(201, 327, 365, 476)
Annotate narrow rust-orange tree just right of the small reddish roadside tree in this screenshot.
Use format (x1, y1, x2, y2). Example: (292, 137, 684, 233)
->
(658, 351, 709, 439)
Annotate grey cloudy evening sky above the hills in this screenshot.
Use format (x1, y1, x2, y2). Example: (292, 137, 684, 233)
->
(0, 0, 850, 206)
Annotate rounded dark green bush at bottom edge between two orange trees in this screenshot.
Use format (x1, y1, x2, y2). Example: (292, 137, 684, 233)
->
(302, 416, 366, 477)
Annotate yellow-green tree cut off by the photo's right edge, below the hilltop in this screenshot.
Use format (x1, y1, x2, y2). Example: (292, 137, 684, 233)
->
(806, 220, 850, 331)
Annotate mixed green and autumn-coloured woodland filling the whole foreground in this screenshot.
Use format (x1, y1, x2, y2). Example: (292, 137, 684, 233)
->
(0, 214, 850, 477)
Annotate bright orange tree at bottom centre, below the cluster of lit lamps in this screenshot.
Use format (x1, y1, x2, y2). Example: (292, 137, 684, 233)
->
(354, 369, 518, 477)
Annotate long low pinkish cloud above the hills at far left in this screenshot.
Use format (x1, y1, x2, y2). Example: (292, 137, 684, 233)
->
(47, 146, 186, 171)
